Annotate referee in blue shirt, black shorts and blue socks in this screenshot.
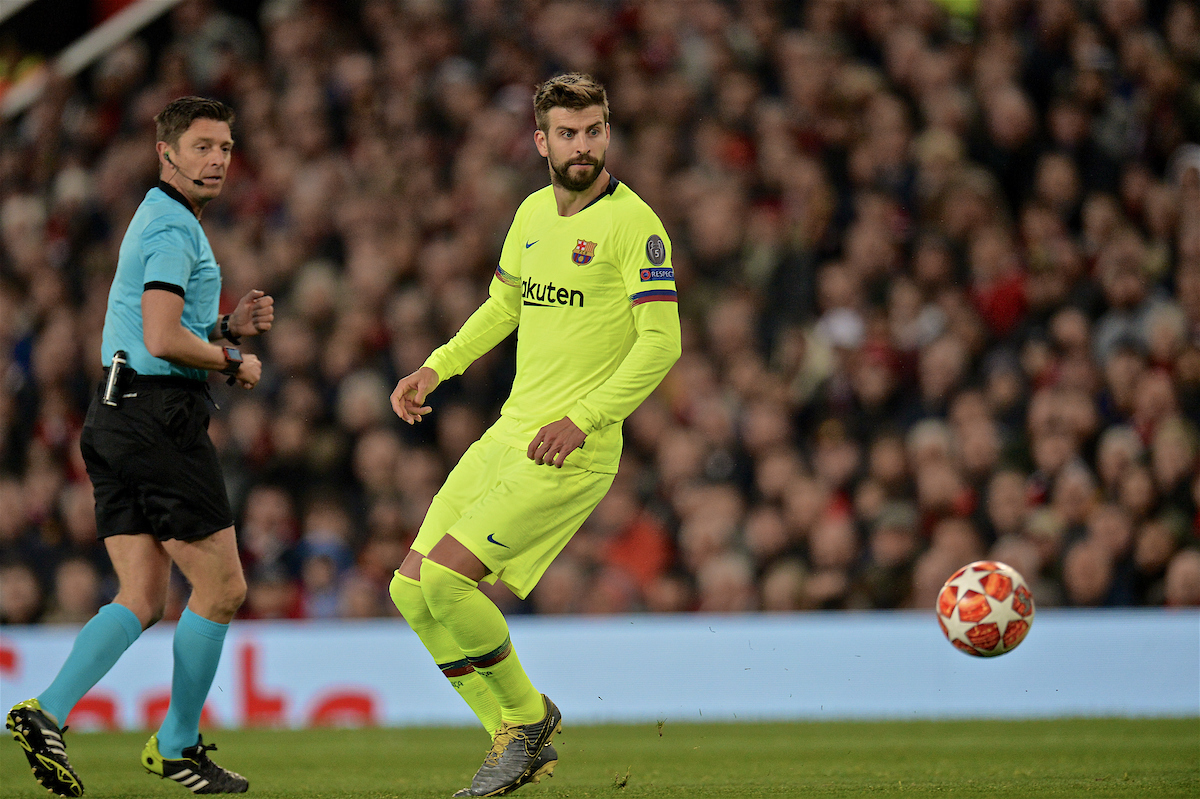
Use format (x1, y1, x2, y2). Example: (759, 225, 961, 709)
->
(7, 97, 275, 797)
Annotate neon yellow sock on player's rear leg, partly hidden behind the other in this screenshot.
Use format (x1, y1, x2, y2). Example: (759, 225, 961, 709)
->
(390, 571, 500, 738)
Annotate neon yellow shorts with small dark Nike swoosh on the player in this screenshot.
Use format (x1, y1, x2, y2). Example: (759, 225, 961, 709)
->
(413, 435, 617, 599)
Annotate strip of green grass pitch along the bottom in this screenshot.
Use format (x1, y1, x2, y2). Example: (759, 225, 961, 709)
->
(0, 719, 1200, 799)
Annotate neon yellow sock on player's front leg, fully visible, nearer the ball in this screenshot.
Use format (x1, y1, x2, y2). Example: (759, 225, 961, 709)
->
(421, 558, 546, 725)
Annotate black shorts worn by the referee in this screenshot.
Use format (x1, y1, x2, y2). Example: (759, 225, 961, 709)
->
(79, 376, 233, 541)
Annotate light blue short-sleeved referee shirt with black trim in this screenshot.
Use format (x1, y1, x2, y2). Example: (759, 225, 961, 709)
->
(100, 182, 221, 380)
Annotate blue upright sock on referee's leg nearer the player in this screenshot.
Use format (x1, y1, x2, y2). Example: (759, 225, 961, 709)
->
(158, 608, 229, 761)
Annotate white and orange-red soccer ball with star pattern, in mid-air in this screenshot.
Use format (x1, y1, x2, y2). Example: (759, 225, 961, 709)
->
(937, 560, 1033, 657)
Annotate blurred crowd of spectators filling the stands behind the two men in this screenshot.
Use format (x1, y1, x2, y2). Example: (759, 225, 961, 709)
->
(0, 0, 1200, 624)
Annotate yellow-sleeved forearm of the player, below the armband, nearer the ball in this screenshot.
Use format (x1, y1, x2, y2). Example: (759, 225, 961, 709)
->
(566, 320, 682, 434)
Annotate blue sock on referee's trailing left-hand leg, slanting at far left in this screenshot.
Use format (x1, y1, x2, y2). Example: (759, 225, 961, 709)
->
(37, 603, 142, 727)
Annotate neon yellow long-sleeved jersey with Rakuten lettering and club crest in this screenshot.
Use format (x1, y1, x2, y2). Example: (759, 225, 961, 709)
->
(425, 179, 680, 473)
